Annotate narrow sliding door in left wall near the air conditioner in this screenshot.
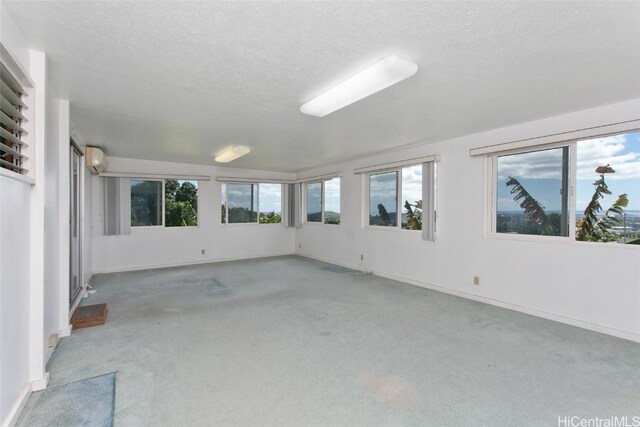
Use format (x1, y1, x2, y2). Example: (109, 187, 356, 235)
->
(69, 140, 83, 306)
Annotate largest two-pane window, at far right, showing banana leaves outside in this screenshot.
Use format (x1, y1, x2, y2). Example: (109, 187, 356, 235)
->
(492, 132, 640, 243)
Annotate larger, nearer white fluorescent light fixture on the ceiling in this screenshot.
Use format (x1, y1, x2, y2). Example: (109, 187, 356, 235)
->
(300, 55, 418, 117)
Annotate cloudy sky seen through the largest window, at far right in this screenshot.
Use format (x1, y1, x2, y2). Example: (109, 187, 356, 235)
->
(498, 132, 640, 213)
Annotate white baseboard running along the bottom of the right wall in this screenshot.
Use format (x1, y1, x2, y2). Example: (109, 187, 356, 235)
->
(297, 252, 640, 343)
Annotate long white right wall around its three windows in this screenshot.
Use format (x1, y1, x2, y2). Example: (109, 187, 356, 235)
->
(296, 100, 640, 341)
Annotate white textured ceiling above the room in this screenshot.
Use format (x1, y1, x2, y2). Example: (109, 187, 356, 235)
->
(4, 1, 640, 171)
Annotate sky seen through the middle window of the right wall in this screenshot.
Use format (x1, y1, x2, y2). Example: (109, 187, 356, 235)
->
(369, 165, 422, 216)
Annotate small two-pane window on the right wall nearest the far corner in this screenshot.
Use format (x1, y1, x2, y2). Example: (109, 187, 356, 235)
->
(307, 177, 341, 225)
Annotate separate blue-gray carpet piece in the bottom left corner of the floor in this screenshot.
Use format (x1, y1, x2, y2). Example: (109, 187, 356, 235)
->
(17, 372, 116, 427)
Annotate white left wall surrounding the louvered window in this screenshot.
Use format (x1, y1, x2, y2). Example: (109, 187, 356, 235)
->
(0, 4, 76, 426)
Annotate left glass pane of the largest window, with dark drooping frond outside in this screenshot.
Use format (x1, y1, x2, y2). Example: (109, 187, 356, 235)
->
(496, 147, 569, 236)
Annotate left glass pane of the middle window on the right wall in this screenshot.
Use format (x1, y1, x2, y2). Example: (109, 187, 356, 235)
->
(369, 172, 398, 227)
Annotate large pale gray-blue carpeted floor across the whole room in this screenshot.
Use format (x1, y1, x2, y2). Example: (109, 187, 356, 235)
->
(38, 257, 640, 427)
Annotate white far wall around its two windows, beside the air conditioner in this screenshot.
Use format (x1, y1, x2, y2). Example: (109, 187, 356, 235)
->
(92, 158, 295, 273)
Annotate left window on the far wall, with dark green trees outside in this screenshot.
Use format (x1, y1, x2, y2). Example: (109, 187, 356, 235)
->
(131, 179, 198, 227)
